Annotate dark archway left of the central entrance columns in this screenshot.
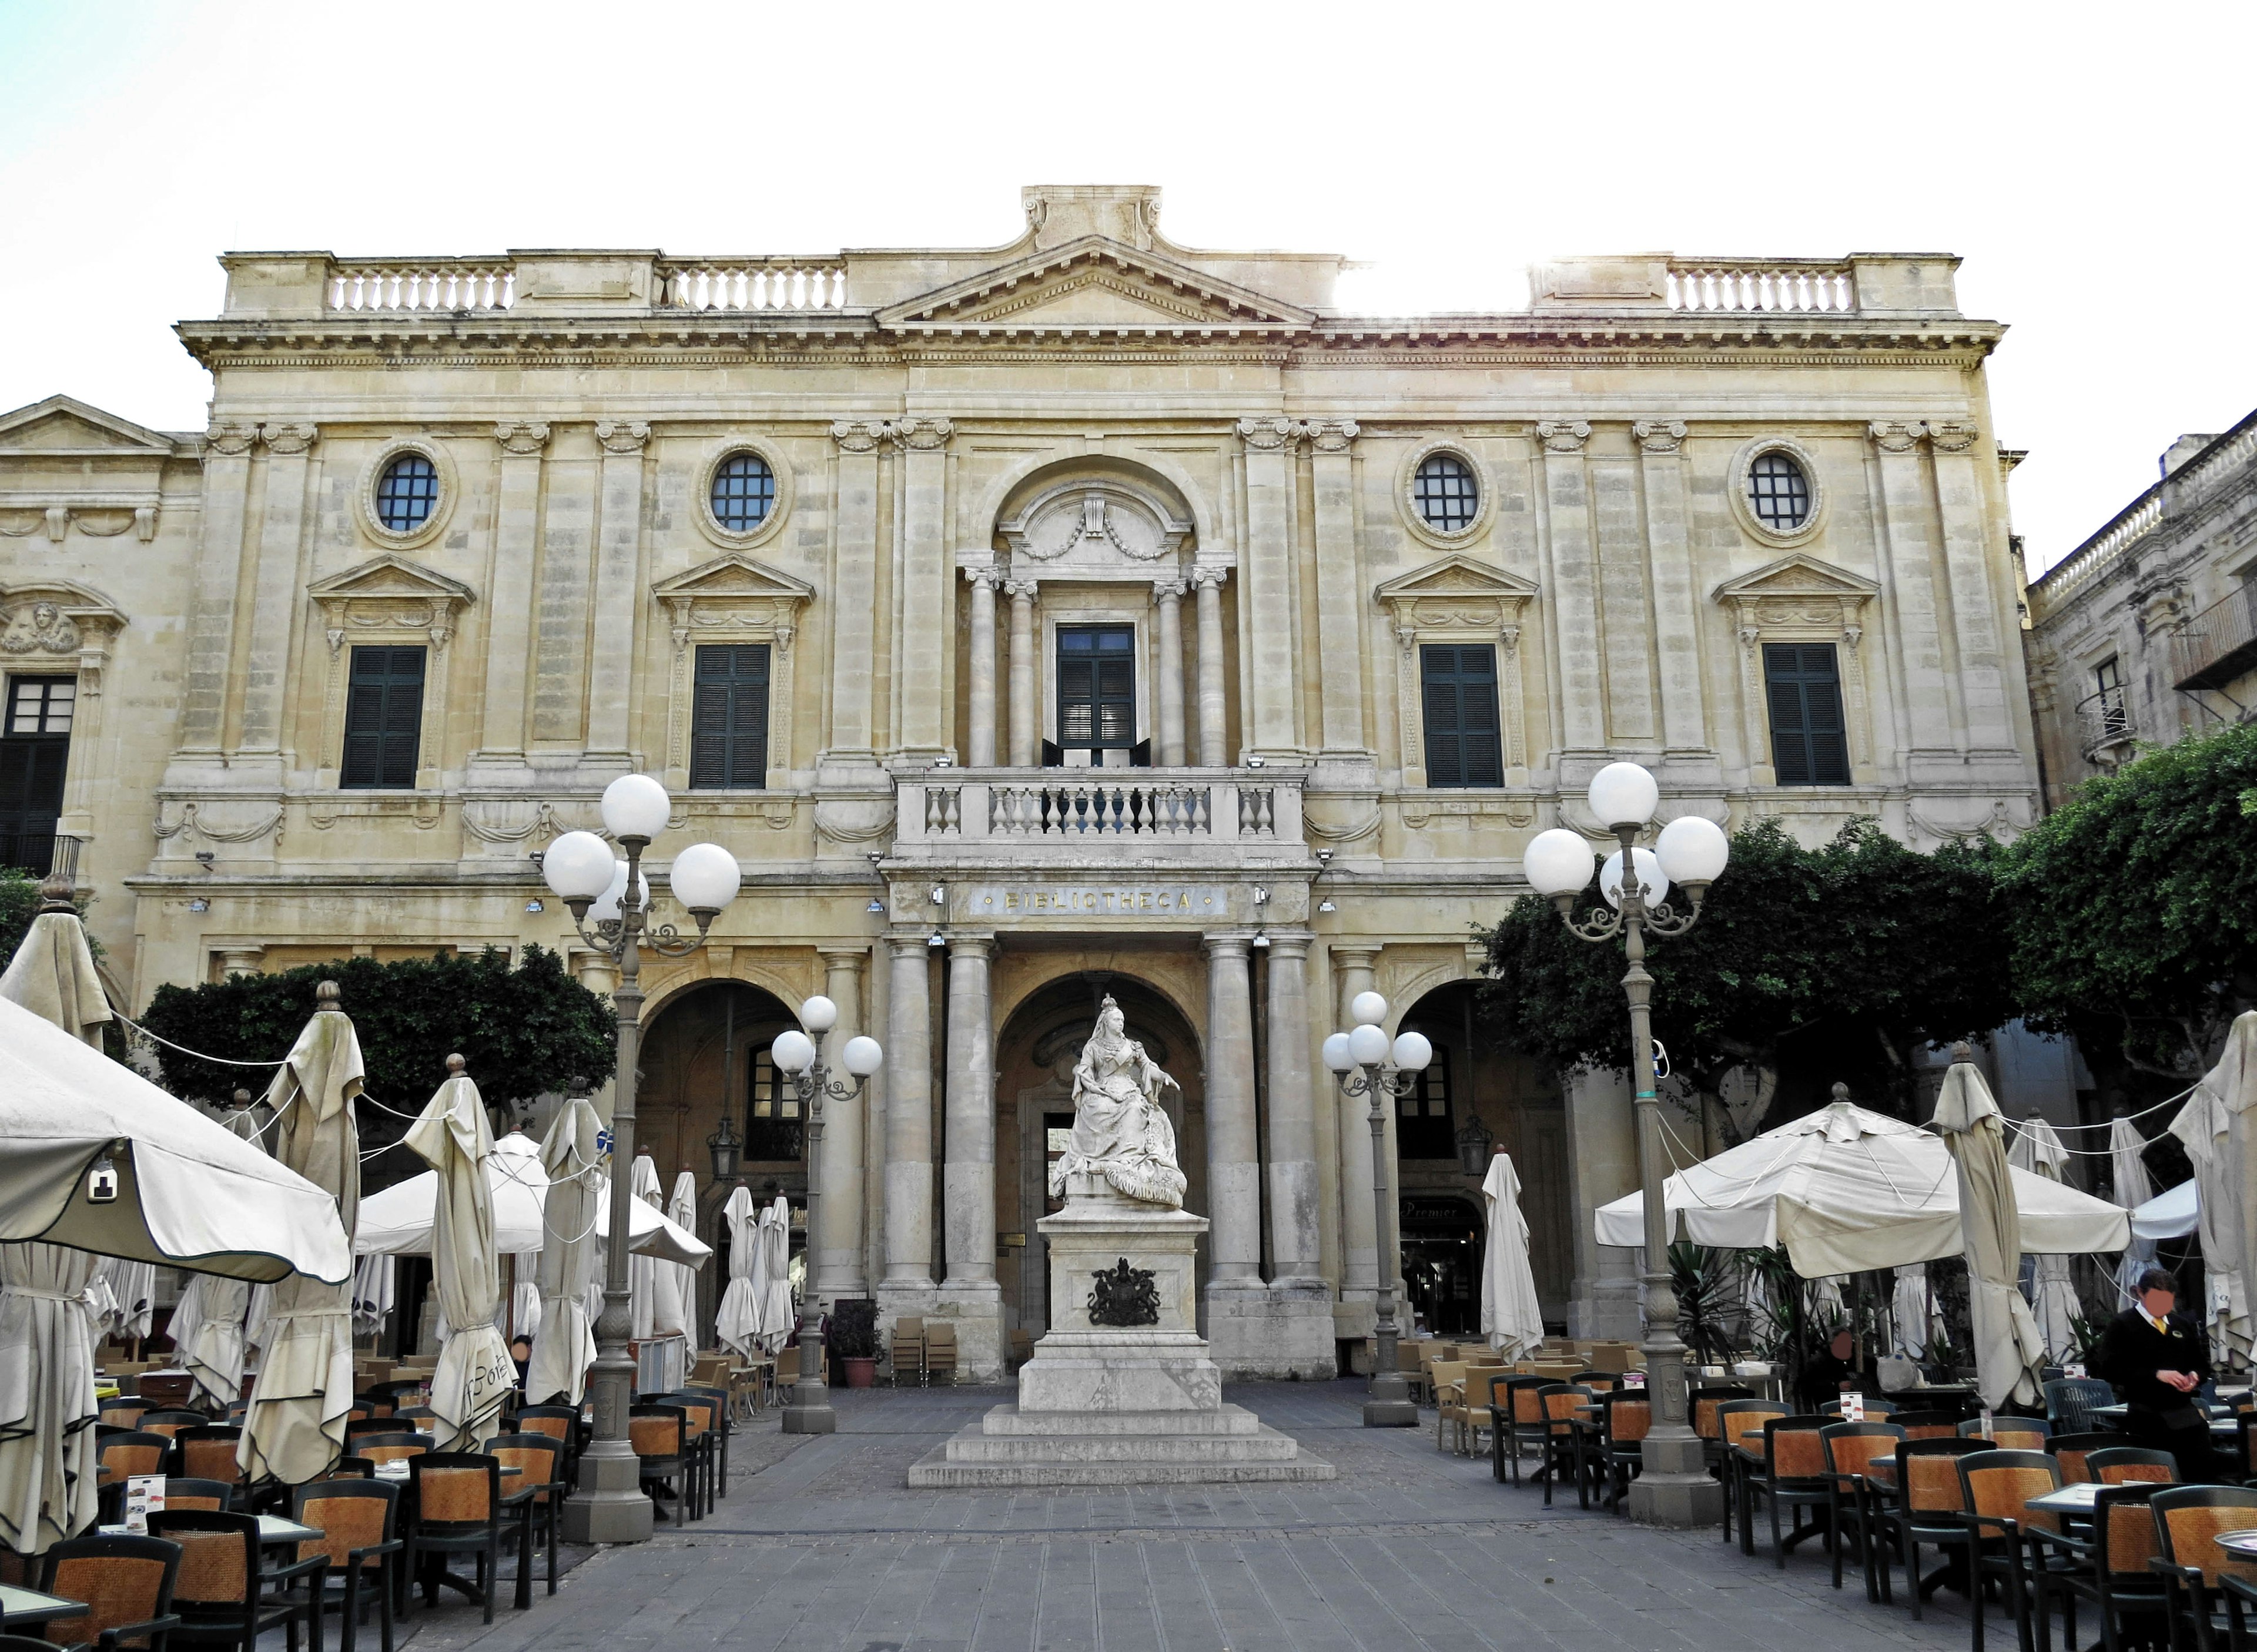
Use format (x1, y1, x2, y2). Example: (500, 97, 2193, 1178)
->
(634, 981, 808, 1348)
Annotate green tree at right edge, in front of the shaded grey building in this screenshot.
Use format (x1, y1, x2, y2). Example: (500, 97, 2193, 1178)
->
(2000, 725, 2257, 1079)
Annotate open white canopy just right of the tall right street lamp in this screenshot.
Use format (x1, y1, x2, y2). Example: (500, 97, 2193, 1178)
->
(1598, 1101, 2131, 1279)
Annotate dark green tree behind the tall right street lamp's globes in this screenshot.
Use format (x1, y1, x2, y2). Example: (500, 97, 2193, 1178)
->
(1485, 819, 2015, 1137)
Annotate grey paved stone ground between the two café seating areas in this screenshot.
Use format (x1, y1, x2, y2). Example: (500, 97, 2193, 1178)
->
(393, 1381, 2011, 1652)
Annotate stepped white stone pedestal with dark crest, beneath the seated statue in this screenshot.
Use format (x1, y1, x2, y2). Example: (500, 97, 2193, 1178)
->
(910, 1176, 1334, 1487)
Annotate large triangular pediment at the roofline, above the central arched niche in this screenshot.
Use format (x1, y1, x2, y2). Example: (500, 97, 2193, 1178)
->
(876, 234, 1316, 332)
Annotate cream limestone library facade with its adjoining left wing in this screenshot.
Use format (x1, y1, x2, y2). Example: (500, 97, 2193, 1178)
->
(0, 187, 2038, 1375)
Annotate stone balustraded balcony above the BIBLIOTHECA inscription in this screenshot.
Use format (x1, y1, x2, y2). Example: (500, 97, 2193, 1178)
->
(894, 768, 1309, 867)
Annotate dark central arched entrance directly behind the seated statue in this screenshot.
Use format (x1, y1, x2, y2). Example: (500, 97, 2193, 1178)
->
(995, 970, 1207, 1338)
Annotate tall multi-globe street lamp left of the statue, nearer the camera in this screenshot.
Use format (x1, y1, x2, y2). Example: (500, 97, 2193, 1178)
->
(542, 774, 742, 1544)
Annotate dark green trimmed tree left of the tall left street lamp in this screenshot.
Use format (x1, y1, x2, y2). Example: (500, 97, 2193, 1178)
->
(142, 946, 614, 1135)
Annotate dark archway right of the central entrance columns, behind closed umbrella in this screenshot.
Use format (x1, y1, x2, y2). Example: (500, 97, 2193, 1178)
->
(1395, 981, 1575, 1336)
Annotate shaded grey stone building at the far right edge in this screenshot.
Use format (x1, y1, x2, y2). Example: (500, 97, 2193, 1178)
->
(2029, 413, 2257, 808)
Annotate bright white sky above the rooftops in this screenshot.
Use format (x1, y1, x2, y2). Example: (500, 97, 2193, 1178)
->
(0, 0, 2257, 567)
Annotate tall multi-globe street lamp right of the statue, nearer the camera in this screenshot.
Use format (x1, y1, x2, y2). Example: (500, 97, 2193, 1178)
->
(1521, 763, 1731, 1526)
